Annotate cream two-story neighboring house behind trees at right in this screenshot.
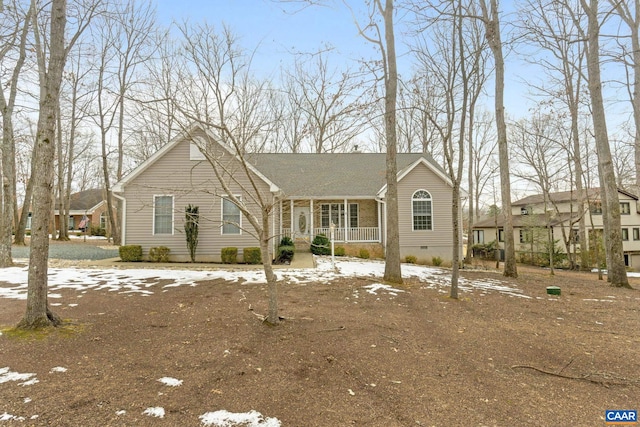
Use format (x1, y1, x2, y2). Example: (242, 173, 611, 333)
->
(473, 189, 640, 268)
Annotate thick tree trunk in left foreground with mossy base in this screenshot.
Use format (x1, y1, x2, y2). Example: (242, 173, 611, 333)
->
(18, 0, 67, 329)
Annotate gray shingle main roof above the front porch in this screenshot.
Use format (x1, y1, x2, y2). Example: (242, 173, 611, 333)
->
(247, 153, 442, 198)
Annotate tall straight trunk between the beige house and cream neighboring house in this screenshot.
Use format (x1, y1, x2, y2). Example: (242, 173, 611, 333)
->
(480, 0, 518, 277)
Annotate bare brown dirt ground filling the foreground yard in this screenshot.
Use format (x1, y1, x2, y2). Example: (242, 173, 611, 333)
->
(0, 246, 640, 427)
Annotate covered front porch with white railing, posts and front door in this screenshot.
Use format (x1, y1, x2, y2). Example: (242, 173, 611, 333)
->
(279, 198, 384, 243)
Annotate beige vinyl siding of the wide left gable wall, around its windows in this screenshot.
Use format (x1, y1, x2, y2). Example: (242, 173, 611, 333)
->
(124, 132, 273, 261)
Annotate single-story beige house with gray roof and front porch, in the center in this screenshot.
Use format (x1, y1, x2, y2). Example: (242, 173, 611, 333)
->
(114, 127, 460, 262)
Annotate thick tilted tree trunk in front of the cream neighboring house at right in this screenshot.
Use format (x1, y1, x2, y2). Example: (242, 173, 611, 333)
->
(580, 0, 631, 288)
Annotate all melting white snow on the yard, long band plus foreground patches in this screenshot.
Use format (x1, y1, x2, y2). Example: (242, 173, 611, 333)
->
(0, 257, 531, 427)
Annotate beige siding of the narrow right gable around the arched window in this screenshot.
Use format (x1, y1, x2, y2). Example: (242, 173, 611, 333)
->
(398, 164, 453, 261)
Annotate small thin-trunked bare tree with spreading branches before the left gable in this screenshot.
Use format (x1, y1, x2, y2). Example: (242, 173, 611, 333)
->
(175, 24, 280, 324)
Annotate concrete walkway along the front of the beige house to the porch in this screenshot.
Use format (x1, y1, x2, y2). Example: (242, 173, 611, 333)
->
(75, 252, 316, 270)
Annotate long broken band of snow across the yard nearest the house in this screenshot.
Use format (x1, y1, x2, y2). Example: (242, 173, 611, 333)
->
(0, 257, 531, 307)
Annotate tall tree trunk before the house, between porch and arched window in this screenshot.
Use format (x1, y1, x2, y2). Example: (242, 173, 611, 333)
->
(380, 0, 402, 283)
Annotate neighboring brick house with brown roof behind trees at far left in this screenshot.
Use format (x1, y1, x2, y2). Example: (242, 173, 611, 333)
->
(52, 189, 109, 230)
